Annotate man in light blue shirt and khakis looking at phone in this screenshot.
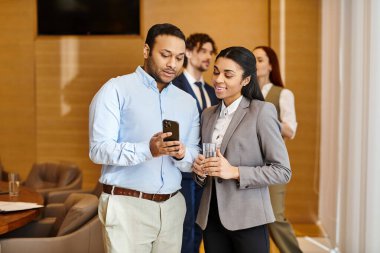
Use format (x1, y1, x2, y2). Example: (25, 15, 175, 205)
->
(89, 24, 199, 253)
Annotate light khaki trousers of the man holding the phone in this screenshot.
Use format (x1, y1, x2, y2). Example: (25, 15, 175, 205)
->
(99, 193, 186, 253)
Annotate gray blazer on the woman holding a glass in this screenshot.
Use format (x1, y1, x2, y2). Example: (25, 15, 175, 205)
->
(194, 97, 291, 230)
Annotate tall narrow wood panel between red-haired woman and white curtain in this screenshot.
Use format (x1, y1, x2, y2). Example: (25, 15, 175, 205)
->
(285, 0, 320, 223)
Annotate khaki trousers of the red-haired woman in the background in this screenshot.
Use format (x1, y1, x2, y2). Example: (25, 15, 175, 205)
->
(269, 185, 302, 253)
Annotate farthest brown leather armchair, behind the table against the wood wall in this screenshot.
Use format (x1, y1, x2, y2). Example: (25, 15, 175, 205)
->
(23, 163, 82, 202)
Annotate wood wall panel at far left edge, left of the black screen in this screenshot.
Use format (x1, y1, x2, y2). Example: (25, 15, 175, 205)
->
(0, 0, 36, 178)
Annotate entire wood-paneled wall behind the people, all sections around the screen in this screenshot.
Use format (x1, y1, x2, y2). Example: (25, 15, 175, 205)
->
(0, 0, 320, 222)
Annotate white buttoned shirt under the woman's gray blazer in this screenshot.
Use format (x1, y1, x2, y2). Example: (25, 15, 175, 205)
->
(212, 96, 243, 148)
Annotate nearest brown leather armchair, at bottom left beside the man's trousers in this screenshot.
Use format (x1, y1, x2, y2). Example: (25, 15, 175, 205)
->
(0, 193, 104, 253)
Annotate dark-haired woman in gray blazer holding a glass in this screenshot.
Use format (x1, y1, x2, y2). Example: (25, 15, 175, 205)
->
(193, 47, 291, 253)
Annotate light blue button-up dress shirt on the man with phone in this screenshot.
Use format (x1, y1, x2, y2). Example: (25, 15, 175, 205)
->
(89, 67, 200, 194)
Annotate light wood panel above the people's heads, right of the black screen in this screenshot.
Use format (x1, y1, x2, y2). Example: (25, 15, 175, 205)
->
(143, 0, 269, 83)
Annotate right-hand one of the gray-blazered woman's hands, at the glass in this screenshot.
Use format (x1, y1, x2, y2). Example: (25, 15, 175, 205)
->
(203, 149, 240, 180)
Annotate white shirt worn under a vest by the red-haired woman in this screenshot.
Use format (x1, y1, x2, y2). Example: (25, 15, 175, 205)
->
(261, 83, 297, 139)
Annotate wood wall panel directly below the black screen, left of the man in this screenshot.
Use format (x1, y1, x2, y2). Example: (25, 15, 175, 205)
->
(36, 36, 142, 188)
